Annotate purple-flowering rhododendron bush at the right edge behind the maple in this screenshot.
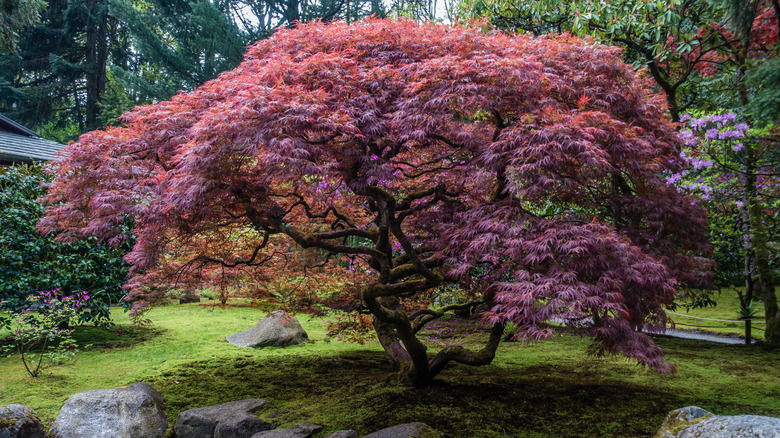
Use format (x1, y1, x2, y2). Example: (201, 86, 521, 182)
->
(668, 113, 780, 286)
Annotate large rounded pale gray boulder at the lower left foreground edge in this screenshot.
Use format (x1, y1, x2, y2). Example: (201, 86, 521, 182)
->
(51, 382, 168, 438)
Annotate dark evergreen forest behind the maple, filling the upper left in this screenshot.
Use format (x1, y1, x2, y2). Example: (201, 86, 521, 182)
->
(0, 0, 454, 142)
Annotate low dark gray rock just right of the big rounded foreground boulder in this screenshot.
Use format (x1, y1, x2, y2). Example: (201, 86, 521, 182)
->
(174, 398, 276, 438)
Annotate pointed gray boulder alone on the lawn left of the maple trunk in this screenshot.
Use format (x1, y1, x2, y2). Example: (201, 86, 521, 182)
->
(227, 310, 309, 348)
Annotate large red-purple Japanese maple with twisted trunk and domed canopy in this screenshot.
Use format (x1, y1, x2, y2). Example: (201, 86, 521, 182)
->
(41, 20, 710, 385)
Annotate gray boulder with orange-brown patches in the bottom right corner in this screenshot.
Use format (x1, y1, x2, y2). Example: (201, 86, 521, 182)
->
(655, 406, 780, 438)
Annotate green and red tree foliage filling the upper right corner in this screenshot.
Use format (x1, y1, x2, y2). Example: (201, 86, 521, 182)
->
(461, 0, 780, 122)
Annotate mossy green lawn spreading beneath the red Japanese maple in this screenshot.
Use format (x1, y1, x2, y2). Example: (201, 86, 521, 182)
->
(0, 304, 780, 437)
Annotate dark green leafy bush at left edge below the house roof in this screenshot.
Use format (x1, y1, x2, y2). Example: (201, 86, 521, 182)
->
(0, 165, 130, 325)
